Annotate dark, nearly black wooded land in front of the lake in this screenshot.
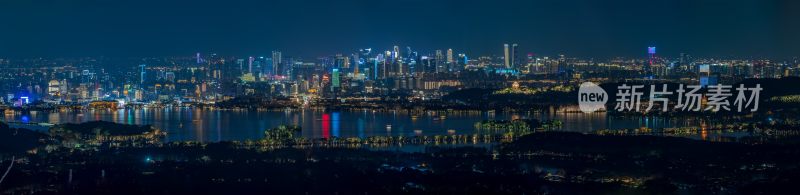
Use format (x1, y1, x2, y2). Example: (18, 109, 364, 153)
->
(0, 123, 800, 194)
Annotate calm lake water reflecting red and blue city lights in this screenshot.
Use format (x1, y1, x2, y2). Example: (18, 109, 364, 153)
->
(1, 108, 700, 142)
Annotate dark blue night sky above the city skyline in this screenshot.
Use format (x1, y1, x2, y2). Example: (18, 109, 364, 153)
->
(0, 0, 800, 58)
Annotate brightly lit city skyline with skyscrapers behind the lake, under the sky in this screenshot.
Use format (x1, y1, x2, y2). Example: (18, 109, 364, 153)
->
(0, 44, 800, 109)
